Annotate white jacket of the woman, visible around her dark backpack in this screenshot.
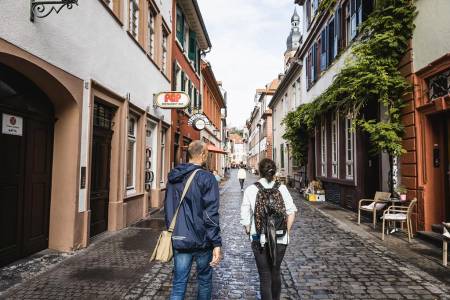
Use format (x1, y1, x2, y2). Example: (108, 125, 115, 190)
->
(241, 178, 297, 245)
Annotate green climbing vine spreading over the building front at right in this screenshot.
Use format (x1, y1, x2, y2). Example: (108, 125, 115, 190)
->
(283, 0, 416, 165)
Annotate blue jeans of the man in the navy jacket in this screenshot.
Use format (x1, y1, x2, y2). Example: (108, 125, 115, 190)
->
(170, 249, 212, 300)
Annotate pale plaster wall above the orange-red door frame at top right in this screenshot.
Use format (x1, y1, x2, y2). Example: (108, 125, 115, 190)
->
(412, 0, 450, 71)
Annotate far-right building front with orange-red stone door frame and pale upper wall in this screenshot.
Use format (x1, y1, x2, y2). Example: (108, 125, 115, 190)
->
(400, 0, 450, 231)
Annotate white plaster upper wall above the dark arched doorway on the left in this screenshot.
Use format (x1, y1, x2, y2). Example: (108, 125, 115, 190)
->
(0, 0, 172, 119)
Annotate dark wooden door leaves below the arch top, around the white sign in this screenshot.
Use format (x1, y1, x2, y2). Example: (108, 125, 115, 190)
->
(0, 109, 53, 265)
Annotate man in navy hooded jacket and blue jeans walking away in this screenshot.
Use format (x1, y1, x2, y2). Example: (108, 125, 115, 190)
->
(164, 141, 222, 300)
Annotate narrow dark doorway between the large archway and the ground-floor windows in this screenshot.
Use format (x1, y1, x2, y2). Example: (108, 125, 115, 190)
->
(90, 102, 113, 236)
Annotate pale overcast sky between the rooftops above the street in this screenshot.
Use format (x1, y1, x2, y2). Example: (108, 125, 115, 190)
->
(198, 0, 300, 127)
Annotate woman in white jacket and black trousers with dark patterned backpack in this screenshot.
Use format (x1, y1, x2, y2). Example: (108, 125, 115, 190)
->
(241, 158, 297, 300)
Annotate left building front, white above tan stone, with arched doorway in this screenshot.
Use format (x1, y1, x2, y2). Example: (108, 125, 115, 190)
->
(0, 0, 173, 265)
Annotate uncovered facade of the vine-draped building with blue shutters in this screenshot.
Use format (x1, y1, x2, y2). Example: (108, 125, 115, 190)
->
(296, 0, 389, 209)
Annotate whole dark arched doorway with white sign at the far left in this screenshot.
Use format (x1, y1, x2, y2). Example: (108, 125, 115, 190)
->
(0, 64, 55, 265)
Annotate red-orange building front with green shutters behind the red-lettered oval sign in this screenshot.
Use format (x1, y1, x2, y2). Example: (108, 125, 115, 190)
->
(171, 0, 211, 166)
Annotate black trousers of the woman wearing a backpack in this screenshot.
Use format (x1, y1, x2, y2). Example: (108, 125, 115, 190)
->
(252, 242, 287, 300)
